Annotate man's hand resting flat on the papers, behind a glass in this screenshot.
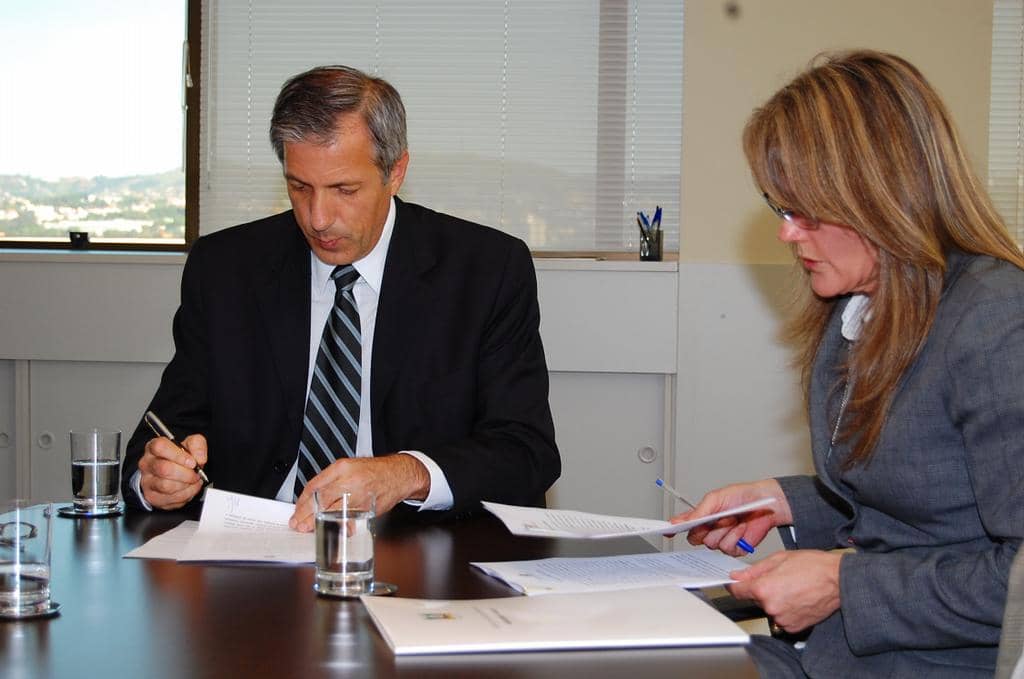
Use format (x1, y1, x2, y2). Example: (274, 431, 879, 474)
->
(288, 454, 430, 533)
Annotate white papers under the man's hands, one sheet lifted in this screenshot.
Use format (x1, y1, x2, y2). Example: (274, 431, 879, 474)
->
(125, 487, 316, 563)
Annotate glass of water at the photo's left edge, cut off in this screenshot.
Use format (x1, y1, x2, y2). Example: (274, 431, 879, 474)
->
(0, 500, 59, 619)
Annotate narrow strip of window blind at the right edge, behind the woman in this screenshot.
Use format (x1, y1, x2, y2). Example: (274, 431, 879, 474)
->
(988, 0, 1024, 244)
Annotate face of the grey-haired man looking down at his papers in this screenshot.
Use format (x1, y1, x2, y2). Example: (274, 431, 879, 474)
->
(284, 114, 409, 265)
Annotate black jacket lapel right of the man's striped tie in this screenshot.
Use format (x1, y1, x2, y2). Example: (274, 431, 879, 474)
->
(370, 198, 437, 444)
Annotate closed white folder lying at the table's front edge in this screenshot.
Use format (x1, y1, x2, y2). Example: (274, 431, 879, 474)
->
(361, 587, 750, 655)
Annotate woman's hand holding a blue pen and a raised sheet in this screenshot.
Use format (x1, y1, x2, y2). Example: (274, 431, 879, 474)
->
(670, 478, 793, 556)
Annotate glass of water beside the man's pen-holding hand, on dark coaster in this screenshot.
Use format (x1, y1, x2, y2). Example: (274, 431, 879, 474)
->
(67, 428, 124, 516)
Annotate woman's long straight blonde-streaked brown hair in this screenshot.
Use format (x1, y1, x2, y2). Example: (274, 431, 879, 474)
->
(743, 50, 1024, 467)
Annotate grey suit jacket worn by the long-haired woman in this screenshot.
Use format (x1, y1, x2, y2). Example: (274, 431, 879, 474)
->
(779, 253, 1024, 679)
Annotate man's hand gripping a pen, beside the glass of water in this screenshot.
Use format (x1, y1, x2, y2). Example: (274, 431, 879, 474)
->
(138, 434, 206, 509)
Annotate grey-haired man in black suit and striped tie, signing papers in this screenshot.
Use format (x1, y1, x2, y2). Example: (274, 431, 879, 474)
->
(123, 67, 560, 531)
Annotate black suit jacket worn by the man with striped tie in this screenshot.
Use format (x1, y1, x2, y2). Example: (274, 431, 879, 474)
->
(123, 199, 560, 515)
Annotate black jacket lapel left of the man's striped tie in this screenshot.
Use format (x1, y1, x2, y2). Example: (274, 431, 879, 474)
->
(253, 216, 310, 422)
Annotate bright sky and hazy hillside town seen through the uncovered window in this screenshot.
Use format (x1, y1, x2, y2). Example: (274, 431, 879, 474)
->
(0, 0, 186, 240)
